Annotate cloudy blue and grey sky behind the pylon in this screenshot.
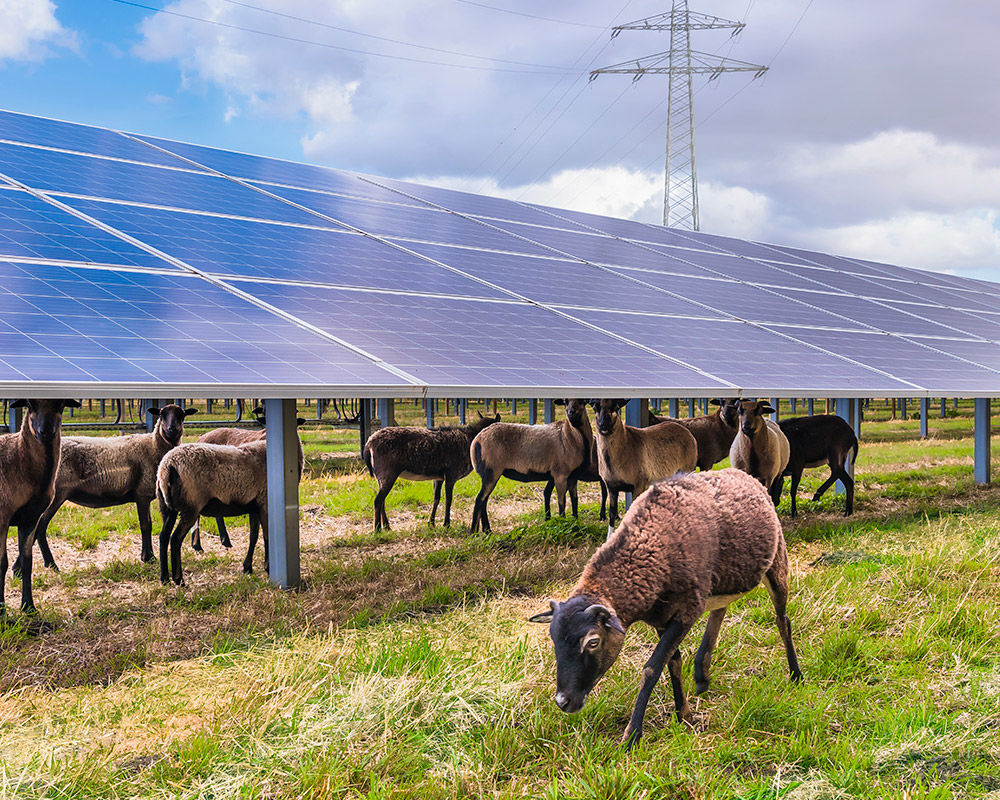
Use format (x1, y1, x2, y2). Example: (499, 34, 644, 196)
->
(0, 0, 1000, 281)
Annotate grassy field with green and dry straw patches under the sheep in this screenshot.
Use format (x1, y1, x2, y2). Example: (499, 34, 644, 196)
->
(0, 401, 1000, 800)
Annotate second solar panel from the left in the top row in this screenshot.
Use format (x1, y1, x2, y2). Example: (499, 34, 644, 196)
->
(138, 136, 423, 206)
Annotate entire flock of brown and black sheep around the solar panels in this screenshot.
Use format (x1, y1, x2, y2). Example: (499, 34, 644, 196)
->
(0, 399, 858, 747)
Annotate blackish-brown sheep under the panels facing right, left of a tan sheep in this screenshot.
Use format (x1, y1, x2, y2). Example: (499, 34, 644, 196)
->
(362, 414, 500, 531)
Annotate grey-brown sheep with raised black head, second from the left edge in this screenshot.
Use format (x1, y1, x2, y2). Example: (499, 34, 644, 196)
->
(14, 404, 198, 572)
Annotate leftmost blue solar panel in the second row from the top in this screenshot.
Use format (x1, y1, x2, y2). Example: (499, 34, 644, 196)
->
(0, 144, 317, 225)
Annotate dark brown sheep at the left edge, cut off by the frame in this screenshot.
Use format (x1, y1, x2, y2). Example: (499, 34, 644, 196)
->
(0, 400, 80, 633)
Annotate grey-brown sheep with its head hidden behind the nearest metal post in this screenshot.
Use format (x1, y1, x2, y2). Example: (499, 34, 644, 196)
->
(156, 439, 269, 585)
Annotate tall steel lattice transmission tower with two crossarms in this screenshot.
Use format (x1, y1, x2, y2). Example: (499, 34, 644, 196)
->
(590, 0, 767, 231)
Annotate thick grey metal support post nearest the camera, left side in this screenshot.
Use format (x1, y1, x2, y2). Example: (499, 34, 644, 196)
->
(264, 400, 298, 589)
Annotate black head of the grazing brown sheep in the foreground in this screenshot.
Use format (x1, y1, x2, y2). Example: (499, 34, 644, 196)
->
(532, 595, 625, 714)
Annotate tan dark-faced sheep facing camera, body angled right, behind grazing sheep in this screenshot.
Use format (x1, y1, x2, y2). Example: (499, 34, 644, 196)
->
(590, 400, 698, 534)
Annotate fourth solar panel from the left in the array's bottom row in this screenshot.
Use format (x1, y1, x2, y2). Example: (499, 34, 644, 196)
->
(782, 328, 1000, 396)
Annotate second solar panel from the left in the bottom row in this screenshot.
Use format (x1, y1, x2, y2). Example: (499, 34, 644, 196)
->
(225, 283, 723, 392)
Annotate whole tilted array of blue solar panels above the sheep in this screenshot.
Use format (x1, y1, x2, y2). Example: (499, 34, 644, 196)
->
(0, 112, 1000, 397)
